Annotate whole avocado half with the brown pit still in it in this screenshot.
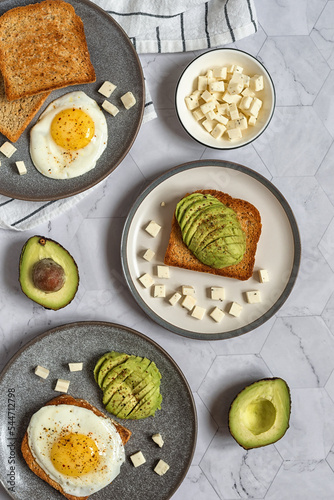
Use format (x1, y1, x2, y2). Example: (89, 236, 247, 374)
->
(19, 236, 79, 311)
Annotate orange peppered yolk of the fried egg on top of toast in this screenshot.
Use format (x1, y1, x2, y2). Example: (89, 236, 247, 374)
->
(51, 434, 100, 477)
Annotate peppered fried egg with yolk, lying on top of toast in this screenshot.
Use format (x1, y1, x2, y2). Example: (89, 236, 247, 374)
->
(27, 404, 125, 497)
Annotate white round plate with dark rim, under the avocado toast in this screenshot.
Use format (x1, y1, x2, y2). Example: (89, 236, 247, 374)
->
(121, 160, 300, 340)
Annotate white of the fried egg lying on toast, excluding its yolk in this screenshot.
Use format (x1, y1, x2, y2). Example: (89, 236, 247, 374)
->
(27, 405, 125, 497)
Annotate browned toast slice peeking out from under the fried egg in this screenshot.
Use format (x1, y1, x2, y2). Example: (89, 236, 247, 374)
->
(21, 394, 131, 500)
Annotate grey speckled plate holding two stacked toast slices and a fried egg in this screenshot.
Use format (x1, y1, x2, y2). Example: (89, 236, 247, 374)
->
(0, 0, 145, 201)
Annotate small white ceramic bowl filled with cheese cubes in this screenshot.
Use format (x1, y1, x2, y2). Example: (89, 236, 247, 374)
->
(175, 49, 276, 149)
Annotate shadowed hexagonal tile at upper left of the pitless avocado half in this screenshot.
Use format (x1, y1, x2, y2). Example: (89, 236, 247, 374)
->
(197, 355, 271, 426)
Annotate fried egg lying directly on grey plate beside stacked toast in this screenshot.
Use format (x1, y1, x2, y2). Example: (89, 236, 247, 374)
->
(30, 91, 108, 179)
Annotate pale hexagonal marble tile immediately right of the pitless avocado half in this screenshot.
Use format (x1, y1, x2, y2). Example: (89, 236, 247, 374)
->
(275, 388, 334, 461)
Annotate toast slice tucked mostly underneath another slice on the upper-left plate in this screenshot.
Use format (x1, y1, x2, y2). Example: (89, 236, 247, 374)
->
(0, 75, 50, 142)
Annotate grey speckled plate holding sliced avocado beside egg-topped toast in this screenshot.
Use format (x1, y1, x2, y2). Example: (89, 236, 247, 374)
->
(0, 322, 197, 500)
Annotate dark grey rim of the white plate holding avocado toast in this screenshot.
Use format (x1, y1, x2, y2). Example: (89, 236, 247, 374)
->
(121, 159, 301, 340)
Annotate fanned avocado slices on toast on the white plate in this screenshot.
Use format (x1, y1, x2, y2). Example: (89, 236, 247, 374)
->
(175, 193, 246, 269)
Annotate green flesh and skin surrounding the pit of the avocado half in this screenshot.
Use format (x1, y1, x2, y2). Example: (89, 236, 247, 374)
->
(19, 235, 80, 311)
